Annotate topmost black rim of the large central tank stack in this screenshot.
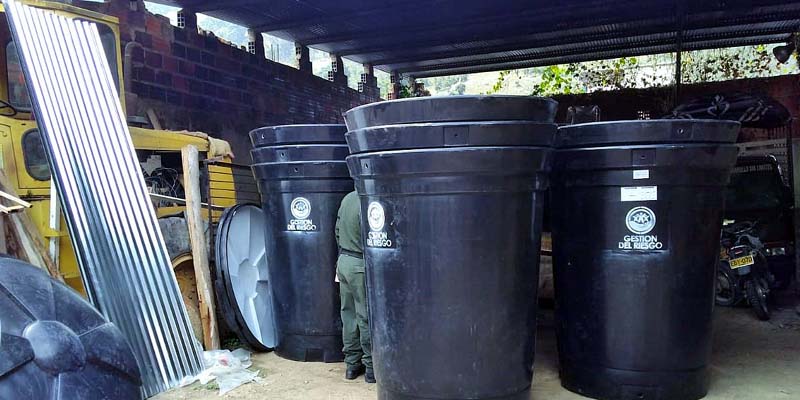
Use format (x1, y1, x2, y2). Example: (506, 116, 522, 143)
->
(344, 96, 558, 131)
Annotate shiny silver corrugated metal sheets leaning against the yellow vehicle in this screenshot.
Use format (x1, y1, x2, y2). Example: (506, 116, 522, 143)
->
(3, 0, 202, 397)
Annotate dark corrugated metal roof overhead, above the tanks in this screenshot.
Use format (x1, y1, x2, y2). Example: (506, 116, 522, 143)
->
(147, 0, 800, 77)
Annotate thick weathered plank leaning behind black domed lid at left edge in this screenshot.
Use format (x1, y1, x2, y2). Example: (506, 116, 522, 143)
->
(0, 169, 64, 282)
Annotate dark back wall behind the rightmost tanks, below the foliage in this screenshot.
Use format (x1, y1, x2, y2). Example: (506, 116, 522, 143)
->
(555, 75, 800, 141)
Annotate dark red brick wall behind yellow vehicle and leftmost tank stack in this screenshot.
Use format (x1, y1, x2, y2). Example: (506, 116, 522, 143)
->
(78, 0, 379, 163)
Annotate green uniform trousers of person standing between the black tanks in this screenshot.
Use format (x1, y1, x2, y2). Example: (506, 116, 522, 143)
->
(336, 254, 372, 369)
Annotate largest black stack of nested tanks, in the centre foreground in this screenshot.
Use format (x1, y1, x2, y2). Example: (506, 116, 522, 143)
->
(346, 96, 556, 400)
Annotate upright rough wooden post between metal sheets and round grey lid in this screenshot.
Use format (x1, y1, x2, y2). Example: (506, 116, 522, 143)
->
(181, 145, 219, 350)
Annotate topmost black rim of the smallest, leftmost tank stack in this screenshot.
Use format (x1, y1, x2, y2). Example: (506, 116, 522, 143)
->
(250, 124, 347, 147)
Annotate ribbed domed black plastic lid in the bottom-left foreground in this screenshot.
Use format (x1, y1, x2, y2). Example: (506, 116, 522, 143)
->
(0, 256, 142, 400)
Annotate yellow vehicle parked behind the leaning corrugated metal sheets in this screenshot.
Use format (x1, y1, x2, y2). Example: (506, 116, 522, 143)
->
(0, 0, 250, 314)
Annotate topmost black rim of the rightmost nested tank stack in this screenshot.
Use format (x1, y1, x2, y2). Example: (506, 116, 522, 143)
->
(556, 119, 740, 148)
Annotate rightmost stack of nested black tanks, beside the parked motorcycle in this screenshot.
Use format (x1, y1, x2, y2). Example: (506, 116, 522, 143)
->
(552, 120, 739, 400)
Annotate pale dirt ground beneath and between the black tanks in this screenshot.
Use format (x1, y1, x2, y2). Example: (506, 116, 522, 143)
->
(155, 294, 800, 400)
